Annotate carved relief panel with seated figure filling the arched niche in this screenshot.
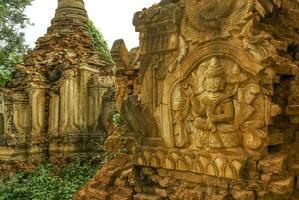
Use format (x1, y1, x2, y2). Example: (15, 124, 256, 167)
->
(172, 57, 279, 155)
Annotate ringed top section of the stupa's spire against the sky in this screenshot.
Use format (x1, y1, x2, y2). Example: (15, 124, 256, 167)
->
(52, 0, 88, 26)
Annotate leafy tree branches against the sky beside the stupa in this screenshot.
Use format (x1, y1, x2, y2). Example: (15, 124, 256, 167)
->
(0, 0, 32, 85)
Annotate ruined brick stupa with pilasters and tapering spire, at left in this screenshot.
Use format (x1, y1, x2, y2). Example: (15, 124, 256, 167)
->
(0, 0, 113, 167)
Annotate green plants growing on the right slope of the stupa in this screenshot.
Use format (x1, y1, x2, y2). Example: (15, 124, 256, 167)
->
(88, 20, 114, 64)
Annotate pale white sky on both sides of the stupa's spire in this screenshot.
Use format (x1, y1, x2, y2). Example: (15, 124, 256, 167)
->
(25, 0, 160, 50)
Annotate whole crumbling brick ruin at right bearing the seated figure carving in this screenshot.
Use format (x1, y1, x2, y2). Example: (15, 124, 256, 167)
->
(102, 0, 299, 200)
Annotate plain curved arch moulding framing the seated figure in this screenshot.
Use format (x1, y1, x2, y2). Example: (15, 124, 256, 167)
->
(161, 42, 264, 147)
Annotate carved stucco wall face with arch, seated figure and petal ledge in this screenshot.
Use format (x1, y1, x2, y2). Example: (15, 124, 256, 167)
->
(131, 0, 281, 179)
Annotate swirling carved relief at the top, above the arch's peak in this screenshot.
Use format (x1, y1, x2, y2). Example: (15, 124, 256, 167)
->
(181, 0, 253, 42)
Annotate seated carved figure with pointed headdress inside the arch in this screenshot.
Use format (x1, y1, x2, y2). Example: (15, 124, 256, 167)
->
(191, 57, 240, 148)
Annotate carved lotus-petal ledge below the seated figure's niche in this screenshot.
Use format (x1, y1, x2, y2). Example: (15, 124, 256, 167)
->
(134, 147, 248, 179)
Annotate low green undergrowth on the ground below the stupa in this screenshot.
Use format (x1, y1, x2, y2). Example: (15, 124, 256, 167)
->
(0, 162, 98, 200)
